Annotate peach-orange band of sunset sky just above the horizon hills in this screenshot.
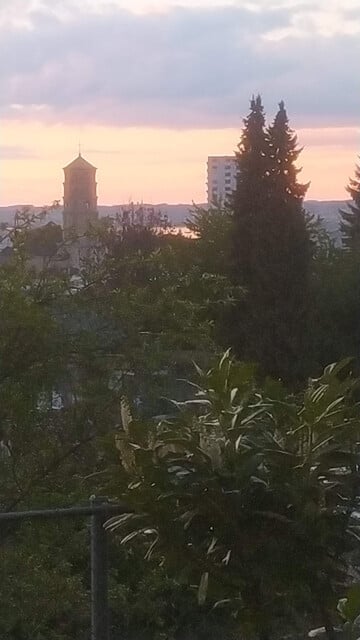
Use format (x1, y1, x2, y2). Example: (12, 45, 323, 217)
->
(0, 120, 359, 206)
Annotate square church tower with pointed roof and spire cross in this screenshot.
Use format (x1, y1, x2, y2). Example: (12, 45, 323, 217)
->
(63, 152, 99, 239)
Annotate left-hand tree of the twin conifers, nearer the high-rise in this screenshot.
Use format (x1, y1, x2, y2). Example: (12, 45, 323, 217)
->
(231, 95, 270, 376)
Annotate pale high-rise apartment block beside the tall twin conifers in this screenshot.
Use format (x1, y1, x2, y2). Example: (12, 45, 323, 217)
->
(207, 156, 237, 204)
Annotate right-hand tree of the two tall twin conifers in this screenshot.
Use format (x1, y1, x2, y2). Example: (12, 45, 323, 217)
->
(267, 101, 310, 379)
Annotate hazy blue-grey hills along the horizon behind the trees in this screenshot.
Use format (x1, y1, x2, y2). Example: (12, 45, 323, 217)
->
(0, 200, 346, 240)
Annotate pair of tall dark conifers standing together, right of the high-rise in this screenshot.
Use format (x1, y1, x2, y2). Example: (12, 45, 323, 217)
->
(233, 97, 310, 380)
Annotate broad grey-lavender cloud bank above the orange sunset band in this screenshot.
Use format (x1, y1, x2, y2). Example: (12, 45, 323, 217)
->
(0, 0, 360, 128)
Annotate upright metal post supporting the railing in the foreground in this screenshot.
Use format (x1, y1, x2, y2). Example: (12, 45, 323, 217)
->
(90, 496, 109, 640)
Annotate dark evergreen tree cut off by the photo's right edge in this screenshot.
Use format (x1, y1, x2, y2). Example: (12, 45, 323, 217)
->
(340, 158, 360, 251)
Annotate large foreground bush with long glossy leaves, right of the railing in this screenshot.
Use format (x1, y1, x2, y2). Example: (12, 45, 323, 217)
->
(108, 354, 358, 634)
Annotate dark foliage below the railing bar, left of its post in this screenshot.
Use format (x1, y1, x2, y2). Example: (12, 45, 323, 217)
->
(0, 522, 90, 640)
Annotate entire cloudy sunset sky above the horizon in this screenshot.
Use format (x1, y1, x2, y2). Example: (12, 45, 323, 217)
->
(0, 0, 360, 205)
